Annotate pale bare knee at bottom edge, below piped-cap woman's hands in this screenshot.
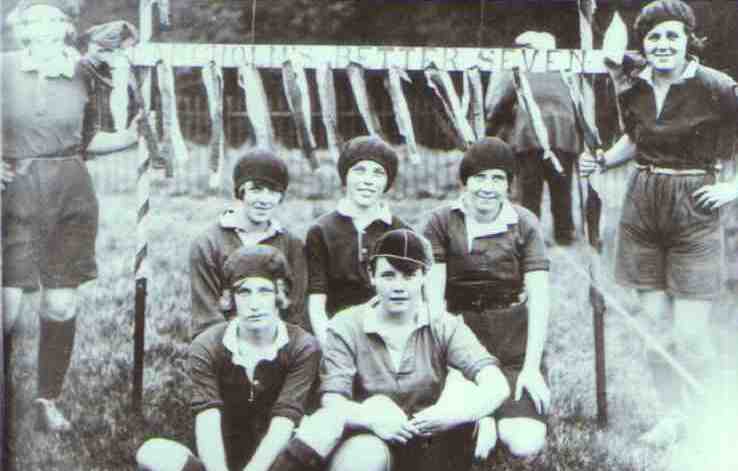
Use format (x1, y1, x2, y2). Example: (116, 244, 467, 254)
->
(328, 433, 392, 471)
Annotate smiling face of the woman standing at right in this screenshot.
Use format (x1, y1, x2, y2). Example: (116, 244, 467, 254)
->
(643, 20, 688, 74)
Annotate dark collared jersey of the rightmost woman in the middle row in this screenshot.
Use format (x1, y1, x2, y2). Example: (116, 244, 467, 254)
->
(423, 202, 549, 297)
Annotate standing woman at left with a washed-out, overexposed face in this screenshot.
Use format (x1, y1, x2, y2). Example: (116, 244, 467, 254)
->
(0, 0, 137, 431)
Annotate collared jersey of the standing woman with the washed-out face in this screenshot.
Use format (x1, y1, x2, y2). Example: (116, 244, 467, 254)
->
(1, 50, 95, 160)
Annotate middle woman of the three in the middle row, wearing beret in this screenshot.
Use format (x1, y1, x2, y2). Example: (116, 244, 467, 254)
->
(305, 136, 408, 345)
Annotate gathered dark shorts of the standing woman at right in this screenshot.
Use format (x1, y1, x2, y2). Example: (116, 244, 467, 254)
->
(615, 170, 723, 300)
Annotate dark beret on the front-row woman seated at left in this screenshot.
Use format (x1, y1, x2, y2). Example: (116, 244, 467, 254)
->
(223, 244, 292, 288)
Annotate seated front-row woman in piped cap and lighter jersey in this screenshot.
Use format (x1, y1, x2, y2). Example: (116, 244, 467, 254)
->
(264, 229, 510, 471)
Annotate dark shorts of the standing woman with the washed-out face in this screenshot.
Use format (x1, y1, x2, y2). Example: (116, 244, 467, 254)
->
(2, 158, 98, 290)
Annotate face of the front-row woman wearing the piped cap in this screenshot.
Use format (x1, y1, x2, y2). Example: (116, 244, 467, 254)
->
(371, 257, 425, 316)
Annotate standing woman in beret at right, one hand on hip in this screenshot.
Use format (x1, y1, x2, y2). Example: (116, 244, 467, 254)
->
(581, 0, 738, 444)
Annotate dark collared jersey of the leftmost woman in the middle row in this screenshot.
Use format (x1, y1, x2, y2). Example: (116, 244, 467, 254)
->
(190, 209, 308, 339)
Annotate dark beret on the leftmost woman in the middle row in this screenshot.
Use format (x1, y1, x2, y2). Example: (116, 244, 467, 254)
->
(233, 148, 290, 198)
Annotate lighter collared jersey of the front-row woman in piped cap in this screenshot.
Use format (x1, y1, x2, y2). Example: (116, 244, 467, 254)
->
(320, 302, 498, 415)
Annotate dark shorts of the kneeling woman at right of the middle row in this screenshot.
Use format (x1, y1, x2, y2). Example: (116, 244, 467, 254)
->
(456, 303, 546, 423)
